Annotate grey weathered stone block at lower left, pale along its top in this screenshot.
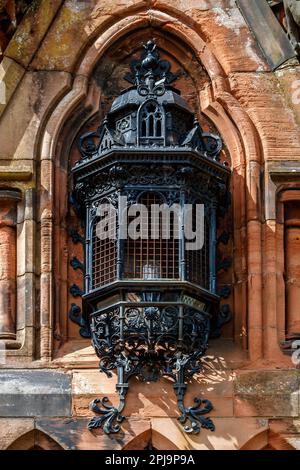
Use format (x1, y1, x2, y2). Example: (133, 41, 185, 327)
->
(0, 370, 71, 417)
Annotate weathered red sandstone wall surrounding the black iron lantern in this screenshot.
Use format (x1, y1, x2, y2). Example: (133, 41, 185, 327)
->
(0, 0, 300, 448)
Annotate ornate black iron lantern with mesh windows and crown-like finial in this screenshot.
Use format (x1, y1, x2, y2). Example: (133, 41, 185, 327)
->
(73, 41, 230, 433)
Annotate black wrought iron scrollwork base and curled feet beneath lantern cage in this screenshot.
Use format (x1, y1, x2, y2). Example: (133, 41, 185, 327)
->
(89, 303, 214, 433)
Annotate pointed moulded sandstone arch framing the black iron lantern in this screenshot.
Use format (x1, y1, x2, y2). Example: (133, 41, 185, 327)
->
(34, 0, 282, 365)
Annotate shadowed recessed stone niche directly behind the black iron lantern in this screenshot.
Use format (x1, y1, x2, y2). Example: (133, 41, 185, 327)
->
(55, 28, 234, 357)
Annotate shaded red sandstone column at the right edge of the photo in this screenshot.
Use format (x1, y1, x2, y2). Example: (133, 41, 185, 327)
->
(285, 201, 300, 335)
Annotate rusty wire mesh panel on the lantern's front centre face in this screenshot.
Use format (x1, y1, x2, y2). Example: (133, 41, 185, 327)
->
(124, 193, 179, 279)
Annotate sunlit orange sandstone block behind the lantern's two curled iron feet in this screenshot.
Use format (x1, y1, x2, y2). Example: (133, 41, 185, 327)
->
(72, 367, 233, 418)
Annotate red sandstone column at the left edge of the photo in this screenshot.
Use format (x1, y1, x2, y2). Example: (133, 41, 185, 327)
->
(0, 189, 21, 342)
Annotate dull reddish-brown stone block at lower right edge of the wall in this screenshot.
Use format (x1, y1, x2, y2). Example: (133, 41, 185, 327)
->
(234, 370, 300, 417)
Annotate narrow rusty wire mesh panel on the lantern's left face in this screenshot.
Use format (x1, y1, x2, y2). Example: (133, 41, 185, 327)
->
(92, 215, 117, 289)
